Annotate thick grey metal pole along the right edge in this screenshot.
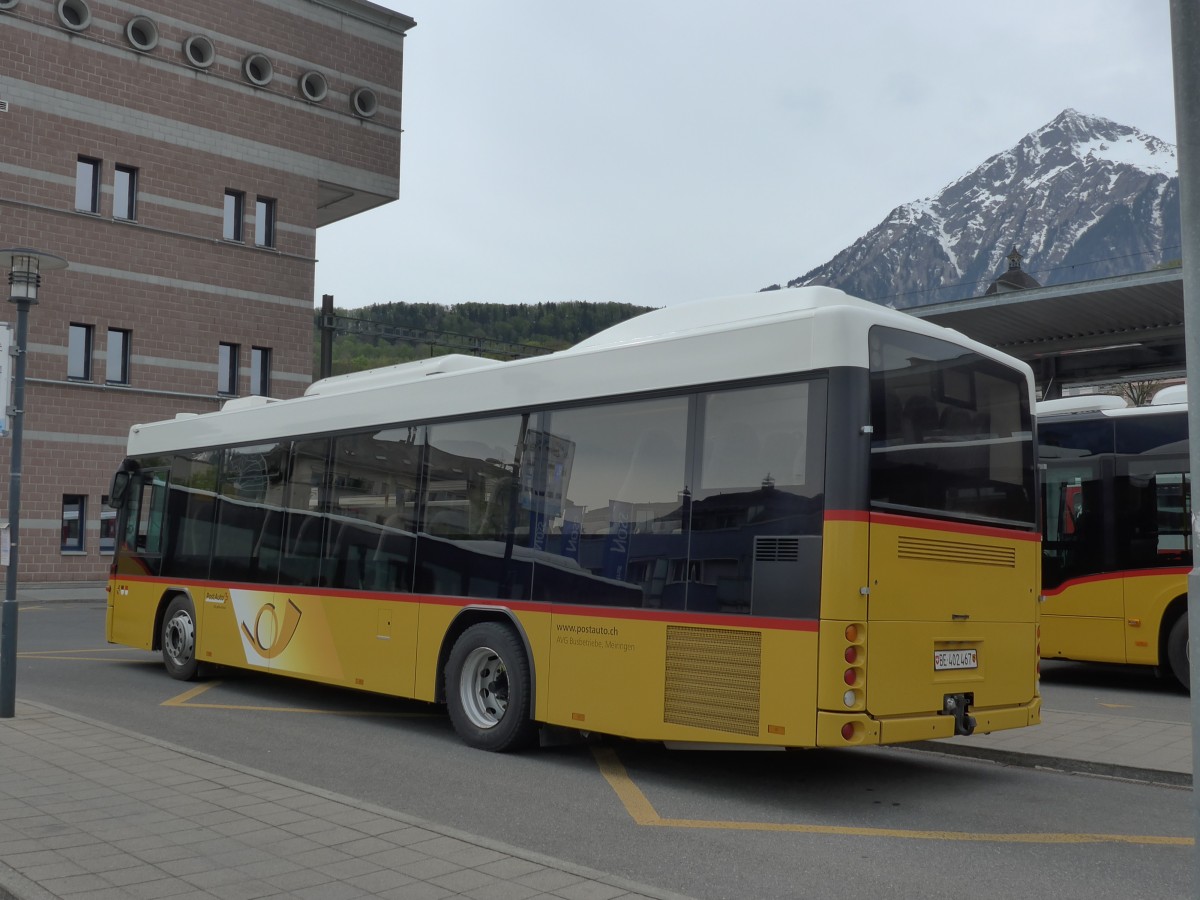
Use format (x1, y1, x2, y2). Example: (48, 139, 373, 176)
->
(1171, 0, 1200, 888)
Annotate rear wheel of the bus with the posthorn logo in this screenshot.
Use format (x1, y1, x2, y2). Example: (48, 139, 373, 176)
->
(445, 622, 538, 752)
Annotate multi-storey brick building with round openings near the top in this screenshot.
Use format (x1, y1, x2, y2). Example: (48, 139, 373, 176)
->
(0, 0, 415, 583)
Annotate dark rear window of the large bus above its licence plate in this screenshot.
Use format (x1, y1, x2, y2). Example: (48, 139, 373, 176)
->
(870, 326, 1036, 524)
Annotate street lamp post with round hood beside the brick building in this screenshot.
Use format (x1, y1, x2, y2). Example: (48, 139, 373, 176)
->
(0, 247, 67, 719)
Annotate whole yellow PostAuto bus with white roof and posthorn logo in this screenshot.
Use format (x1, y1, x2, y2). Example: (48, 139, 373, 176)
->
(107, 288, 1040, 750)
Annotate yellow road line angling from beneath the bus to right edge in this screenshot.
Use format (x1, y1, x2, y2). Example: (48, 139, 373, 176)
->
(592, 748, 1195, 847)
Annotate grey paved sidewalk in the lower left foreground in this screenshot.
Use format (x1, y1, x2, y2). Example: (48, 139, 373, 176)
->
(0, 701, 686, 900)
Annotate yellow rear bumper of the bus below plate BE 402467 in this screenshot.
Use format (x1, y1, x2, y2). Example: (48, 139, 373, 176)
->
(817, 697, 1042, 746)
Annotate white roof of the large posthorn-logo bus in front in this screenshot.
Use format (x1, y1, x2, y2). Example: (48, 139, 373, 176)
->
(128, 287, 1033, 456)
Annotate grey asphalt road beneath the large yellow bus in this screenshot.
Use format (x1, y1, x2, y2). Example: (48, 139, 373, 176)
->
(9, 602, 1196, 900)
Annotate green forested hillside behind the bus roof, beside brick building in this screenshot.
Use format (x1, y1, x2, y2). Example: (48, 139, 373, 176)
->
(313, 301, 652, 378)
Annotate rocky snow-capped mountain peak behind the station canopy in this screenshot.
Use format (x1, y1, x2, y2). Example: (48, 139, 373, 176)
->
(773, 109, 1181, 308)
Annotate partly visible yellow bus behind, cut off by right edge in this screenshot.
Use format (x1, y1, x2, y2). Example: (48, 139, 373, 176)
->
(1037, 389, 1192, 688)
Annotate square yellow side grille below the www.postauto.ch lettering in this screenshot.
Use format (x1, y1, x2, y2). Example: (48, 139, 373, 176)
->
(662, 625, 762, 737)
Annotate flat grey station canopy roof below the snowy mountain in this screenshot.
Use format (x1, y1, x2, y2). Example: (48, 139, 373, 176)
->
(905, 268, 1186, 386)
